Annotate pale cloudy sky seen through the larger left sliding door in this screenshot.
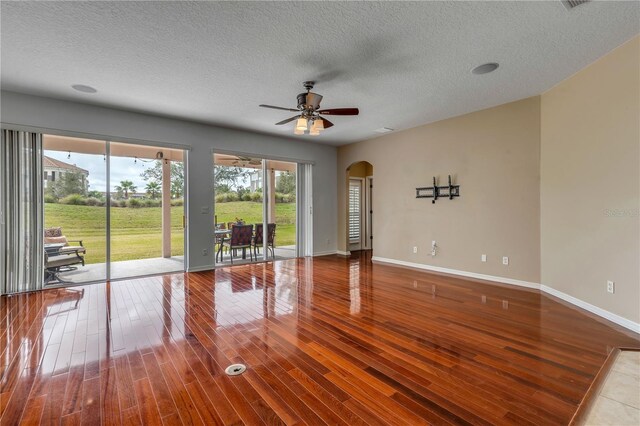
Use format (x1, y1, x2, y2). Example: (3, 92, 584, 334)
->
(44, 150, 155, 192)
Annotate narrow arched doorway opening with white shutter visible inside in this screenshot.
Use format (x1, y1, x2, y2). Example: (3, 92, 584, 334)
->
(346, 161, 373, 252)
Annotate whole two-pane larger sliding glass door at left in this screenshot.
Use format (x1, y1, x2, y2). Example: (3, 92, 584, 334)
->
(42, 135, 184, 285)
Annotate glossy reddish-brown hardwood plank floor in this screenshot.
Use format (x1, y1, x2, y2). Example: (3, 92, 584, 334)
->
(0, 256, 640, 425)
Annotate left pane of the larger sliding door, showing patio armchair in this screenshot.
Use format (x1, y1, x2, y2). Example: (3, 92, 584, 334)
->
(42, 135, 108, 285)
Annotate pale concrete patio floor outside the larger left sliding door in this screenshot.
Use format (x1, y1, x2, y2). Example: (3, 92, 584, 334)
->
(49, 256, 184, 285)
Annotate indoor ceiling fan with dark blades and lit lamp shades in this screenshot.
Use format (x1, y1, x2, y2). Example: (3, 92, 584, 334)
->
(259, 81, 360, 136)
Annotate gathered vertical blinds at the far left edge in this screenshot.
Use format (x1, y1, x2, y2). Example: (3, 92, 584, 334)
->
(0, 129, 44, 294)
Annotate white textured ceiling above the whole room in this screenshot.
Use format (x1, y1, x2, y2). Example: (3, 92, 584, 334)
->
(0, 0, 640, 145)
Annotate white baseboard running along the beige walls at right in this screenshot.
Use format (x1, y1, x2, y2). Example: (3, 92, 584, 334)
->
(371, 256, 640, 334)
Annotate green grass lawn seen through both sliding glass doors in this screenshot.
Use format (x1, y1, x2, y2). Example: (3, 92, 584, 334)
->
(44, 201, 296, 263)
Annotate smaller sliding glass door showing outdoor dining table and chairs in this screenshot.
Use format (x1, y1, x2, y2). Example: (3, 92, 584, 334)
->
(213, 153, 298, 265)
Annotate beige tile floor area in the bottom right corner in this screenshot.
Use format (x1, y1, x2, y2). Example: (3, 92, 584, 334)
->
(585, 351, 640, 426)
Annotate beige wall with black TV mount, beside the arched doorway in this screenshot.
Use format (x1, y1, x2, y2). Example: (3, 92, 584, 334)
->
(338, 97, 540, 282)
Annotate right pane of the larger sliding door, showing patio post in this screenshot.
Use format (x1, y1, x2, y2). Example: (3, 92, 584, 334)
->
(109, 142, 184, 279)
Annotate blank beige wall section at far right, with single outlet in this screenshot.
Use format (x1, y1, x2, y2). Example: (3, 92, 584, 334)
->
(541, 37, 640, 323)
